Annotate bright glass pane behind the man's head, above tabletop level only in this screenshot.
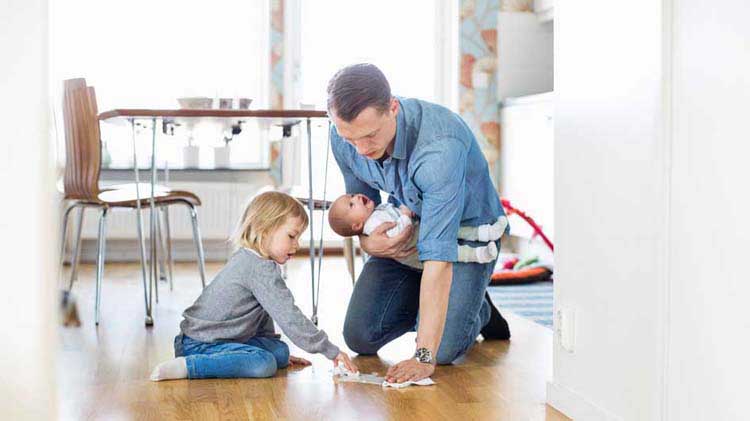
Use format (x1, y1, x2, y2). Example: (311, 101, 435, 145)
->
(300, 0, 437, 109)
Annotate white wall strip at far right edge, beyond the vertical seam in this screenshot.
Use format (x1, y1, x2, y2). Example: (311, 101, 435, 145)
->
(665, 0, 750, 420)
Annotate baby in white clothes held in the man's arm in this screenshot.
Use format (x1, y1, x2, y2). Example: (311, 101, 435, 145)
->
(328, 194, 508, 269)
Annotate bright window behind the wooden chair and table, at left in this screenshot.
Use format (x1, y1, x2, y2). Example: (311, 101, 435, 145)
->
(50, 0, 269, 171)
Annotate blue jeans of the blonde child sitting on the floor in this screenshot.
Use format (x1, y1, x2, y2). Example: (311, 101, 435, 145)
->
(174, 334, 289, 379)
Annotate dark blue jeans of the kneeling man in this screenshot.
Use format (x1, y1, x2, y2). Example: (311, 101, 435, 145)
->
(344, 248, 495, 364)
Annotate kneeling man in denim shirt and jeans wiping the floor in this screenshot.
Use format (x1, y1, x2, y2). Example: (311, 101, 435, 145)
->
(328, 64, 510, 383)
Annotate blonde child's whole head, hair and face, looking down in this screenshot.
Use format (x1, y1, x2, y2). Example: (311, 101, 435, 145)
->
(232, 191, 309, 264)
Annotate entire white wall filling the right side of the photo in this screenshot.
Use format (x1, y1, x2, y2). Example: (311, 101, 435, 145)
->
(548, 0, 750, 420)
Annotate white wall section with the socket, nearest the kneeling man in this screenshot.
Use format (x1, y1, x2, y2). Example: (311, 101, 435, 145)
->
(548, 0, 667, 420)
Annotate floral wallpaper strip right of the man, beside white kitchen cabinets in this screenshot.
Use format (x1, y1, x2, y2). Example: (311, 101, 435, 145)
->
(458, 0, 532, 174)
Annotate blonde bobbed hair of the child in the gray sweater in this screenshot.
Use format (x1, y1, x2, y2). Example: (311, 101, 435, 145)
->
(232, 191, 309, 258)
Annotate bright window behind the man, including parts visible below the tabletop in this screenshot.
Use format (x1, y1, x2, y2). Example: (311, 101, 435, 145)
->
(295, 0, 458, 239)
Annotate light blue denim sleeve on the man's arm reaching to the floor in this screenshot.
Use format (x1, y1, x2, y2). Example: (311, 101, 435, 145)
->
(413, 138, 467, 262)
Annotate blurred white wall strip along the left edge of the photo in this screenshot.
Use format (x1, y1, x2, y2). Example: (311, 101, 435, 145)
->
(0, 0, 57, 420)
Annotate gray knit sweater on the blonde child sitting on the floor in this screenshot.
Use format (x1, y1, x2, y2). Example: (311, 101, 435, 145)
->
(180, 249, 339, 360)
